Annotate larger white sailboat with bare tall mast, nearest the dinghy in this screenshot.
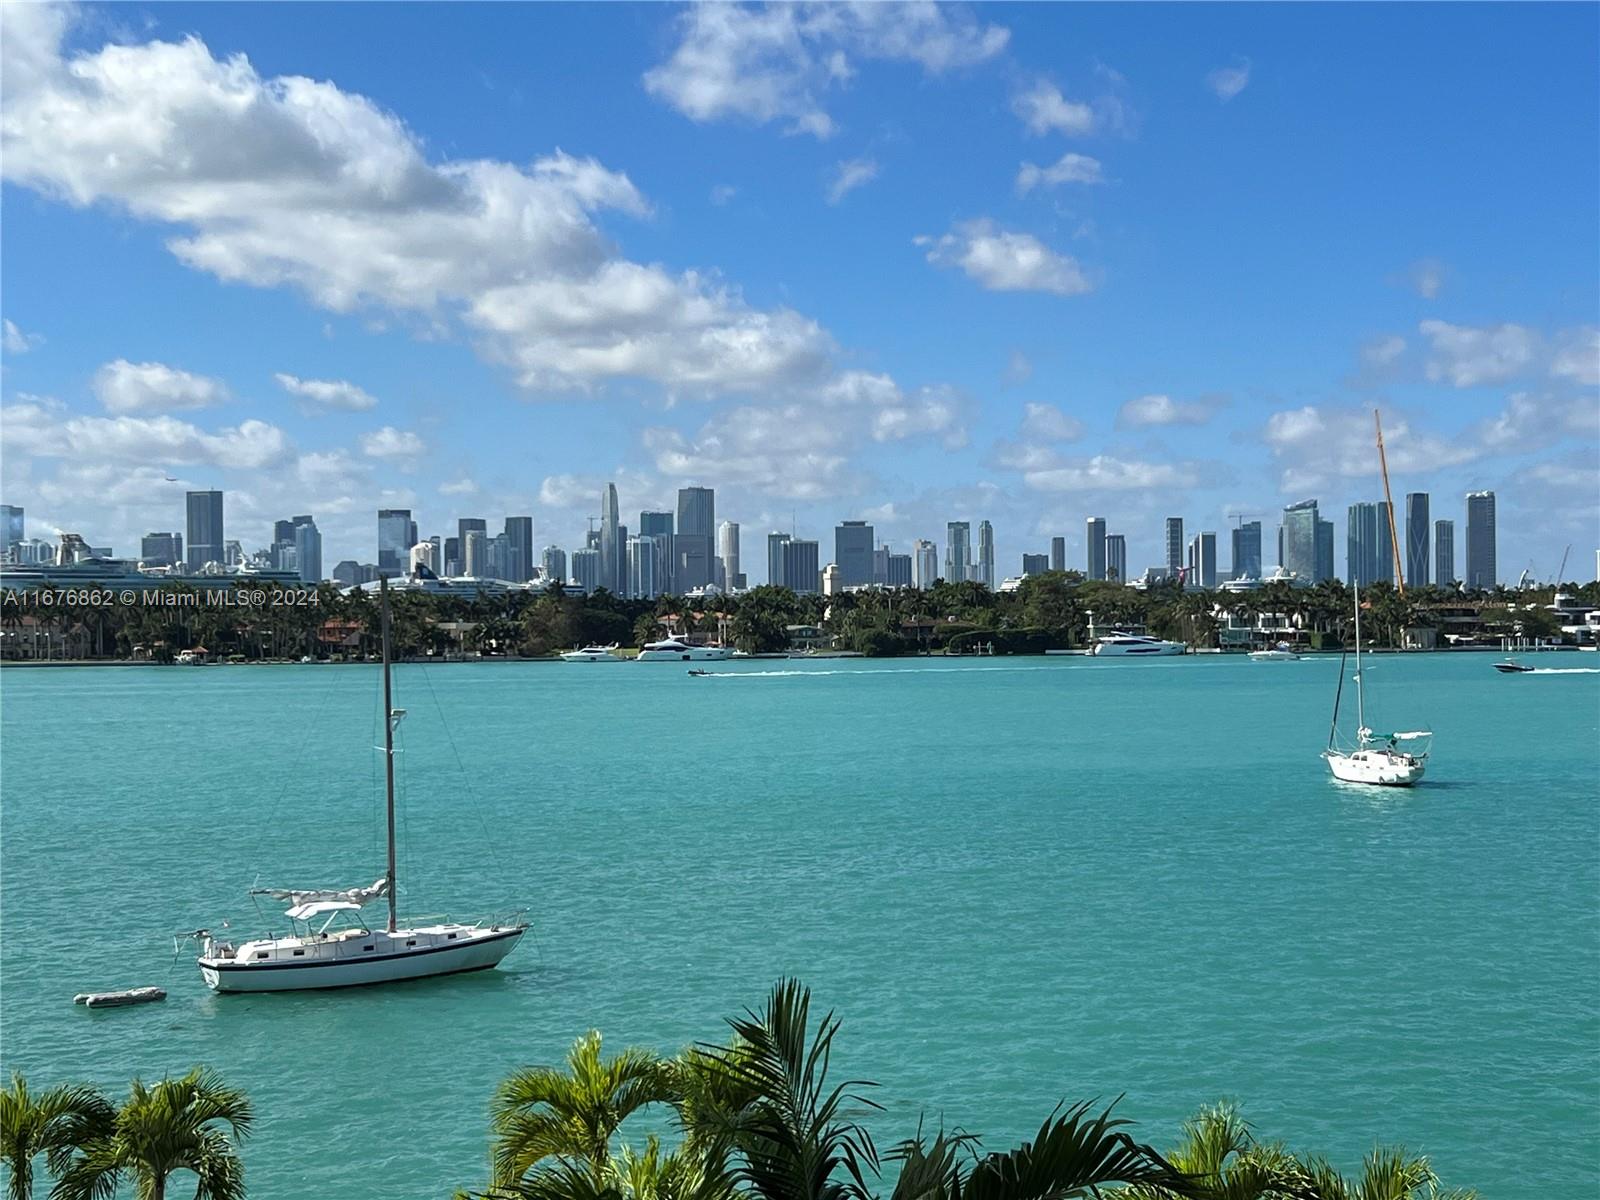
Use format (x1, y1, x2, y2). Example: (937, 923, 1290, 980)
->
(190, 579, 528, 992)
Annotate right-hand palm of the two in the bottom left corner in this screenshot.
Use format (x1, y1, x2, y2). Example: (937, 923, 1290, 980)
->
(51, 1067, 254, 1200)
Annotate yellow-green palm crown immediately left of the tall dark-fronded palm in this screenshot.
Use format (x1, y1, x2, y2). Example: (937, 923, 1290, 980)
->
(493, 1030, 675, 1189)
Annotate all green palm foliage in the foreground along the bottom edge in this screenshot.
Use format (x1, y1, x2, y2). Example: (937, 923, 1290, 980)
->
(0, 979, 1477, 1200)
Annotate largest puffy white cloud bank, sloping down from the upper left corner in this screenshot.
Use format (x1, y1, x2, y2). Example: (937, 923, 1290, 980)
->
(0, 5, 844, 390)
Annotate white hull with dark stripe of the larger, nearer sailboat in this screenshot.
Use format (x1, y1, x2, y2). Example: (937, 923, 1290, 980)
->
(198, 925, 525, 992)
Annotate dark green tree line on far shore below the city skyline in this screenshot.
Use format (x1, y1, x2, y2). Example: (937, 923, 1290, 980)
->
(0, 571, 1600, 664)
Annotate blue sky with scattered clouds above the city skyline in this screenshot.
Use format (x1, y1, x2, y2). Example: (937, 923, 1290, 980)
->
(0, 5, 1600, 579)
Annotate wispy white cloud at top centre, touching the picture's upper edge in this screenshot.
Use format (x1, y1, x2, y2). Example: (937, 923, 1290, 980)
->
(645, 0, 1010, 138)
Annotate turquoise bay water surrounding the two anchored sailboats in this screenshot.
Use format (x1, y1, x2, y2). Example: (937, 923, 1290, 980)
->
(0, 654, 1600, 1200)
